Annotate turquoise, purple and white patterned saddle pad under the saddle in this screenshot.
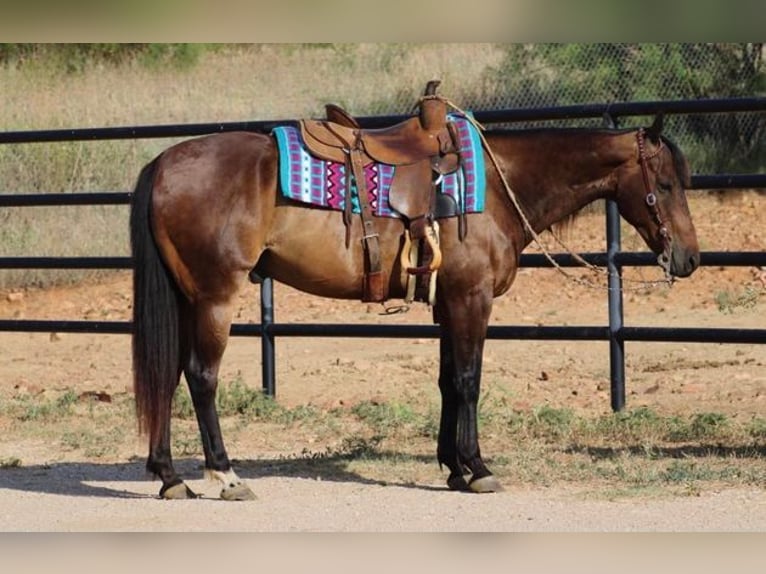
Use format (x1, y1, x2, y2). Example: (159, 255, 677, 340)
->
(272, 114, 486, 217)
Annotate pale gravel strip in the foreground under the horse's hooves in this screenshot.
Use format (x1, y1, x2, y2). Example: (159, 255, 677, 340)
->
(0, 463, 766, 532)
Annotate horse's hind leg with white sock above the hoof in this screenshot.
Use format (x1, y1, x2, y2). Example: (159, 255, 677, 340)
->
(184, 303, 255, 500)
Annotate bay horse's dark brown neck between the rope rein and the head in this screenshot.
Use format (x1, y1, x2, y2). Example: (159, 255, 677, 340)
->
(487, 128, 637, 237)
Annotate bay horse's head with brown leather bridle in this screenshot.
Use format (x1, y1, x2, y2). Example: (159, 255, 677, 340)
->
(616, 115, 700, 278)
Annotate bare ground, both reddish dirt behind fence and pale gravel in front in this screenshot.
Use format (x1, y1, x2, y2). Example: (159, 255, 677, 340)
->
(0, 192, 766, 531)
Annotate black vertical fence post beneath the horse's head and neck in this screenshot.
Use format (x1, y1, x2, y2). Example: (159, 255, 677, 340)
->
(606, 199, 625, 412)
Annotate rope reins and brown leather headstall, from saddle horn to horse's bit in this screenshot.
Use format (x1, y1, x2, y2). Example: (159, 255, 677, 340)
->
(426, 95, 675, 291)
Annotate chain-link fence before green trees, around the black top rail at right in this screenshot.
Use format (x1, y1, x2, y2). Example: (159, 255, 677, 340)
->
(344, 43, 766, 173)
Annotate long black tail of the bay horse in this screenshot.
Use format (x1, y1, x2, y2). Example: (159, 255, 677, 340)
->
(130, 160, 181, 438)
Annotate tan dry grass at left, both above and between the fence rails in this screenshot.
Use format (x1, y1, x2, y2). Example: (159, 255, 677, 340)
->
(0, 44, 500, 288)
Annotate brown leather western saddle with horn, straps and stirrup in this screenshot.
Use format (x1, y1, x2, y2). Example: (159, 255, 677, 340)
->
(300, 80, 460, 304)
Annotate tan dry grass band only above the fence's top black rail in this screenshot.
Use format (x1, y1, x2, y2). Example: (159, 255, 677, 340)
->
(0, 44, 501, 129)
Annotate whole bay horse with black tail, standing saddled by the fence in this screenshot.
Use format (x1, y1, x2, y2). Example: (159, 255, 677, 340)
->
(130, 109, 699, 500)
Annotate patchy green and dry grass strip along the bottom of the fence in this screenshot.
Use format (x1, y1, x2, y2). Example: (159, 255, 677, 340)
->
(0, 380, 766, 498)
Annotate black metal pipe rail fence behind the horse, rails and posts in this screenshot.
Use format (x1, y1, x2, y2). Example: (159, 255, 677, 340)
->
(0, 98, 766, 411)
